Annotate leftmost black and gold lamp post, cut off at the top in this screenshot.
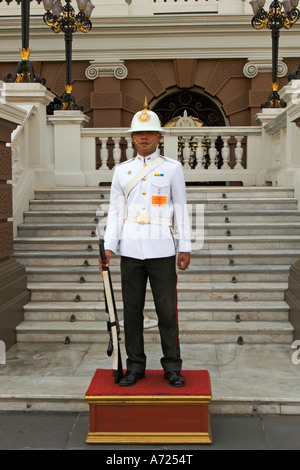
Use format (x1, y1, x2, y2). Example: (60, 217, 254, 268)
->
(0, 0, 46, 85)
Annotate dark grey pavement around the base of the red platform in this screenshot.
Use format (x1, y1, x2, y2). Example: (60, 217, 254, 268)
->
(0, 411, 300, 452)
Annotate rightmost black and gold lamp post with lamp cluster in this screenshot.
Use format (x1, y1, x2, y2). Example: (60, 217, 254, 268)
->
(250, 0, 300, 108)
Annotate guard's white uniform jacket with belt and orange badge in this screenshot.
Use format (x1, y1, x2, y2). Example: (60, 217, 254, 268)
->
(105, 153, 191, 259)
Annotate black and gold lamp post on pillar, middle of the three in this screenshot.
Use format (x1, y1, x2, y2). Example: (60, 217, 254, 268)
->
(43, 0, 94, 110)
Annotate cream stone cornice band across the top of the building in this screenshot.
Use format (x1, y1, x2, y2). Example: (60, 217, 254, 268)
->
(0, 0, 300, 63)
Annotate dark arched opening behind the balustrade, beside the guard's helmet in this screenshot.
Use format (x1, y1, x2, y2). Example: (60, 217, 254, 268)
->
(151, 90, 226, 126)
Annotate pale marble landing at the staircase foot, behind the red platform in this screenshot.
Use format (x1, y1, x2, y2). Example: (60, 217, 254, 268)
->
(0, 342, 300, 416)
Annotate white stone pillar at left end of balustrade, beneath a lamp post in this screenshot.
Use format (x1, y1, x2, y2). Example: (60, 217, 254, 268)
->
(48, 110, 89, 187)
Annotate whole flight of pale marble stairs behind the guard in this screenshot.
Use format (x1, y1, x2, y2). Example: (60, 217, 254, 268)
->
(14, 186, 300, 345)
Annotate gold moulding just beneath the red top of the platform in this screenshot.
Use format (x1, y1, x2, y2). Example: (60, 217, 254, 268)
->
(85, 395, 212, 406)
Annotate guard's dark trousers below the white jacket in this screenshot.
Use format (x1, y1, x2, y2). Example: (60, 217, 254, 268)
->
(121, 256, 182, 372)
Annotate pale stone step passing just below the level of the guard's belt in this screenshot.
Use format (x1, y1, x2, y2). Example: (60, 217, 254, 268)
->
(18, 222, 300, 237)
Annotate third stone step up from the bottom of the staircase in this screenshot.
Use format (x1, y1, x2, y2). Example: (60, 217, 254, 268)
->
(27, 281, 288, 302)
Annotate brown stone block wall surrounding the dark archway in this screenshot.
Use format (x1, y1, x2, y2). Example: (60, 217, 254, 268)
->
(0, 58, 292, 127)
